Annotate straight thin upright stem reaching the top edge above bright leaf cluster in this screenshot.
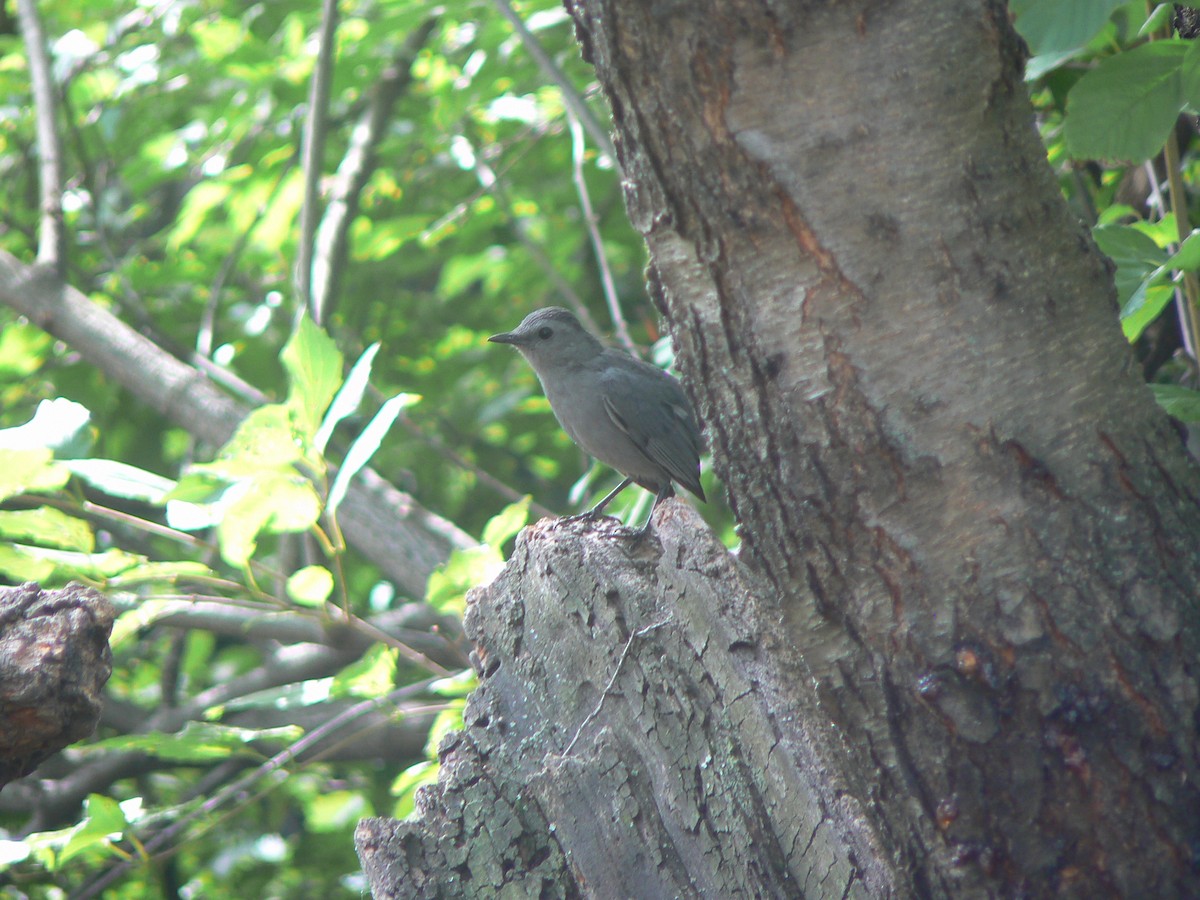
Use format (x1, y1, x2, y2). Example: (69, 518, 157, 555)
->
(294, 0, 337, 325)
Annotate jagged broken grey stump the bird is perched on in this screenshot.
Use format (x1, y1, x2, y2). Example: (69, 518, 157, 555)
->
(358, 511, 889, 900)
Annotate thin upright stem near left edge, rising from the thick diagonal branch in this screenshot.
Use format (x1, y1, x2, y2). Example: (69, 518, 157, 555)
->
(17, 0, 67, 267)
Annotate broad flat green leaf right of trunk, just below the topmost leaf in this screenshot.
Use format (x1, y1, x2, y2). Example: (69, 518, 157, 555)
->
(1066, 41, 1188, 162)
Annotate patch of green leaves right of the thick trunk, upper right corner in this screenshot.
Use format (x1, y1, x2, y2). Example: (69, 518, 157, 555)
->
(1012, 0, 1200, 421)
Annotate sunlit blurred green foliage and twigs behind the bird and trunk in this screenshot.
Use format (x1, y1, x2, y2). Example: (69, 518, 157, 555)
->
(0, 0, 1200, 898)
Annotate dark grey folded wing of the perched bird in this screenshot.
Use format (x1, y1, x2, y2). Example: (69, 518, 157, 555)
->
(602, 364, 704, 499)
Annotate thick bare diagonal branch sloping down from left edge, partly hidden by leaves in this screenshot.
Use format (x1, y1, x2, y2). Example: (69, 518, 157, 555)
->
(0, 251, 476, 596)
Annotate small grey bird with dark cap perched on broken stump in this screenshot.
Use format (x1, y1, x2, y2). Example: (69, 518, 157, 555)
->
(487, 306, 704, 532)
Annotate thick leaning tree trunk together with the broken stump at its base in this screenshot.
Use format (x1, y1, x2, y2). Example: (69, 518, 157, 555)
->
(360, 0, 1200, 898)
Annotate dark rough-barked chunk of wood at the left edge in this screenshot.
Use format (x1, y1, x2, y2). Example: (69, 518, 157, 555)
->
(0, 582, 115, 787)
